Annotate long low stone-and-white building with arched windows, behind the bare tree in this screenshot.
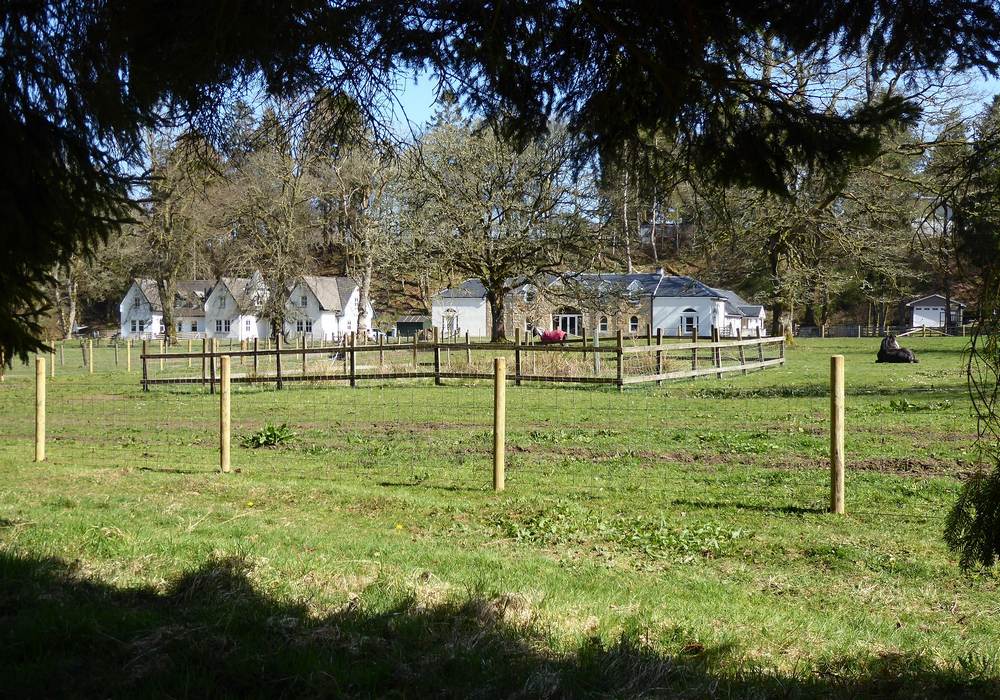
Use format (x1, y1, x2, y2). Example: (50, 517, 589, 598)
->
(431, 270, 766, 337)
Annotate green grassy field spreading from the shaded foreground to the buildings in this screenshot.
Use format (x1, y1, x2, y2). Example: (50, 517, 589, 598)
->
(0, 338, 1000, 697)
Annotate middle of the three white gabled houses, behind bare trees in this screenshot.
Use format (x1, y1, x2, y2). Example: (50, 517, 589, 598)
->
(205, 272, 270, 340)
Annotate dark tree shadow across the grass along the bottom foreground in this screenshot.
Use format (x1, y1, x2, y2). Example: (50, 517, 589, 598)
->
(0, 553, 1000, 698)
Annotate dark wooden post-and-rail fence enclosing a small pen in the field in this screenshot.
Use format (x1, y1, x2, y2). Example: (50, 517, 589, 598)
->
(140, 330, 785, 392)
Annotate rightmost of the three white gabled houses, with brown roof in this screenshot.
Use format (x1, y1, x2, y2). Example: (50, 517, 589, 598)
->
(284, 275, 375, 340)
